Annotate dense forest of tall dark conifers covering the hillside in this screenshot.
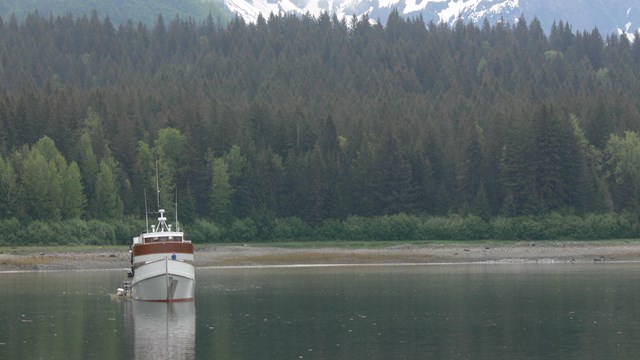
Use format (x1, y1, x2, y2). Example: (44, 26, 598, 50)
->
(0, 12, 640, 242)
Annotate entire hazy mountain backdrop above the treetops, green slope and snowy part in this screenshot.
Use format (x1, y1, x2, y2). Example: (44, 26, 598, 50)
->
(0, 0, 640, 34)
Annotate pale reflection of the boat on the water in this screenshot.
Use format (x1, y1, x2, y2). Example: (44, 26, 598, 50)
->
(125, 301, 196, 360)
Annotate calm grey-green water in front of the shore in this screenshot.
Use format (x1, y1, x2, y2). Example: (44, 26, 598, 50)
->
(0, 264, 640, 360)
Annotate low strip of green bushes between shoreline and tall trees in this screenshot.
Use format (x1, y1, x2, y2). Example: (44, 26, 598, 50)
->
(0, 212, 640, 246)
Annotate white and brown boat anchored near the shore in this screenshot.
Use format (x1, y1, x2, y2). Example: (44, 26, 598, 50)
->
(124, 209, 196, 302)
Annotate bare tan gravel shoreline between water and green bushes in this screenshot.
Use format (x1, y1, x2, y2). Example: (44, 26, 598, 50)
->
(0, 240, 640, 272)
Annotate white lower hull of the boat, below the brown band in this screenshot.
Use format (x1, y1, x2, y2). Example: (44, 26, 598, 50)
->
(131, 257, 195, 302)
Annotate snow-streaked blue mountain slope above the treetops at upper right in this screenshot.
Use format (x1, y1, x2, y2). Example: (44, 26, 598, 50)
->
(224, 0, 640, 34)
